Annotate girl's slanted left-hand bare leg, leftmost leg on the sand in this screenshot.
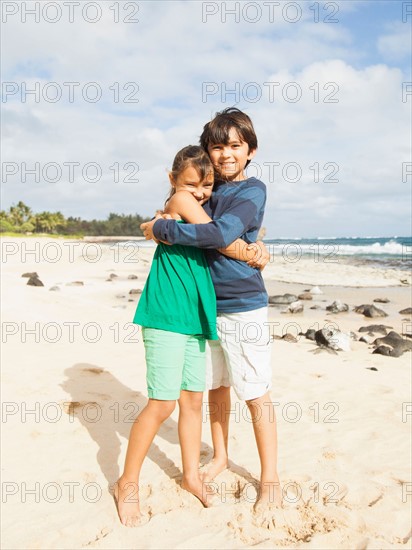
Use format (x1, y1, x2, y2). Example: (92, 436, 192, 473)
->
(114, 399, 176, 527)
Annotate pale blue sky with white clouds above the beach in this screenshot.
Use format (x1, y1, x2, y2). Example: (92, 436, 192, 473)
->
(1, 0, 412, 238)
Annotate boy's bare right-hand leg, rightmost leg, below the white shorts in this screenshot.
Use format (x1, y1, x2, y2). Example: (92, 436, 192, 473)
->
(246, 393, 281, 511)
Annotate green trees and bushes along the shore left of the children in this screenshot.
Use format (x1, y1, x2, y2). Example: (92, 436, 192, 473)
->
(0, 201, 149, 237)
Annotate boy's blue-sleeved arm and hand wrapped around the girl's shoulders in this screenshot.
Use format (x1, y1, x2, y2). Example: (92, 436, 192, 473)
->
(142, 185, 266, 249)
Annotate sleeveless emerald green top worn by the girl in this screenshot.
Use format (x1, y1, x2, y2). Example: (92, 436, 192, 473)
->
(133, 243, 218, 340)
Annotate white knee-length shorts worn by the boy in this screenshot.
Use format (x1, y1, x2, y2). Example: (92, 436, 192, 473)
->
(206, 307, 272, 400)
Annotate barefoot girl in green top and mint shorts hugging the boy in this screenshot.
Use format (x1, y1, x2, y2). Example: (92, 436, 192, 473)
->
(114, 145, 265, 527)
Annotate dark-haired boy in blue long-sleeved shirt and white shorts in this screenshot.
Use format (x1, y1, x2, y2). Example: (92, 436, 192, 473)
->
(141, 107, 280, 509)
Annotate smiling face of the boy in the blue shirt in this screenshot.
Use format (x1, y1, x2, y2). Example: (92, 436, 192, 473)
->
(207, 128, 256, 181)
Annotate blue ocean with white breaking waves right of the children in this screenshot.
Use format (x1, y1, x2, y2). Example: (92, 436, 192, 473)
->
(264, 236, 412, 270)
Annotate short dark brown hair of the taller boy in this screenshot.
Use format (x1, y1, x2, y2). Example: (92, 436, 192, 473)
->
(200, 107, 258, 166)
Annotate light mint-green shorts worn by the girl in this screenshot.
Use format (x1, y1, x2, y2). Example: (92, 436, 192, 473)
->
(142, 327, 206, 401)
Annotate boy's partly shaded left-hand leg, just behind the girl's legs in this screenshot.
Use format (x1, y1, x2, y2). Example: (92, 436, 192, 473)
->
(203, 386, 230, 481)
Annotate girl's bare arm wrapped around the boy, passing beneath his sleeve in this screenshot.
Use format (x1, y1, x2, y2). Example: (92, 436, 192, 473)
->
(165, 191, 270, 269)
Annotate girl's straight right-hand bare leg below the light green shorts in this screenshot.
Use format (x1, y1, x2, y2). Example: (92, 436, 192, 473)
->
(178, 390, 212, 506)
